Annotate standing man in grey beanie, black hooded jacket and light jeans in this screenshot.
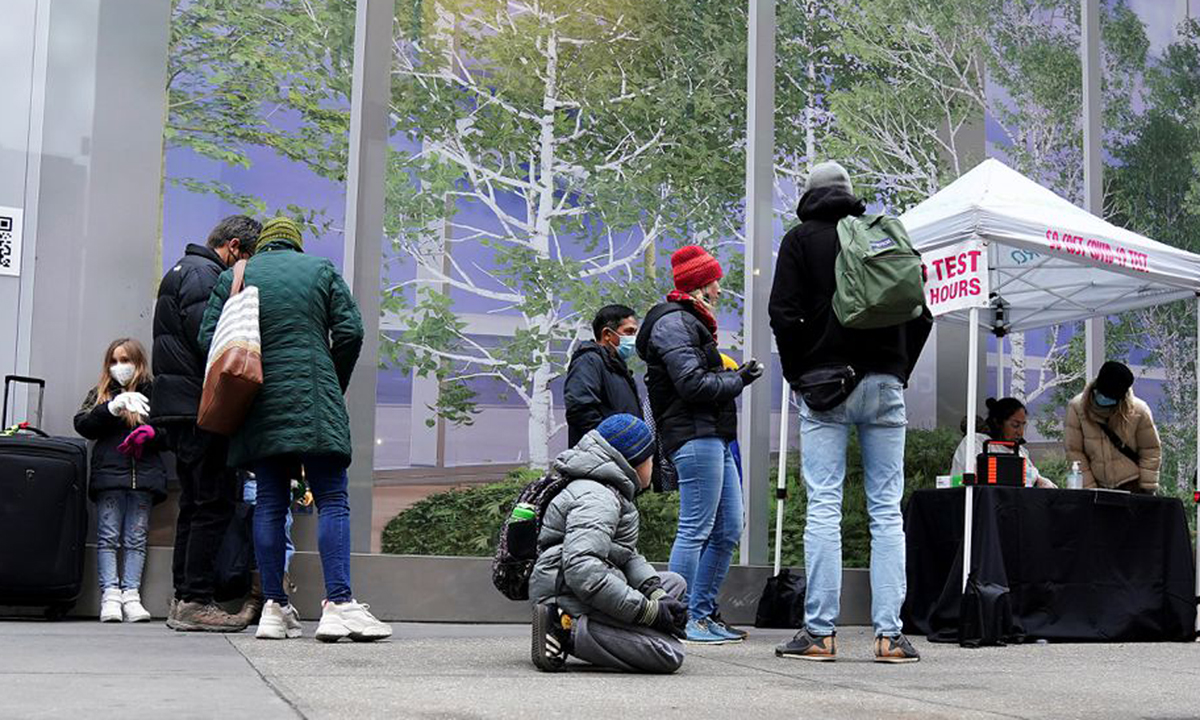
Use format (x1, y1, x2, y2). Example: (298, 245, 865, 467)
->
(770, 162, 932, 662)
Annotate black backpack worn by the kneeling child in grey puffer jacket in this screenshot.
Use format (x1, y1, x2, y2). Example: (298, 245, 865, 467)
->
(492, 473, 574, 600)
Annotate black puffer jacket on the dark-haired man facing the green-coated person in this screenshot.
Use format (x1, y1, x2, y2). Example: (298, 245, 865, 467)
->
(150, 245, 226, 424)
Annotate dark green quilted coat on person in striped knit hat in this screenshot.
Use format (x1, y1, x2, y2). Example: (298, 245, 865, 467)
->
(199, 241, 362, 468)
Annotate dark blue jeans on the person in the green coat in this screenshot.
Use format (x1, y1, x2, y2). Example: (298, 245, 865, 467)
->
(254, 455, 354, 605)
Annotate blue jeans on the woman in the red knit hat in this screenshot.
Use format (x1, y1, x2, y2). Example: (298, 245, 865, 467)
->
(670, 438, 742, 619)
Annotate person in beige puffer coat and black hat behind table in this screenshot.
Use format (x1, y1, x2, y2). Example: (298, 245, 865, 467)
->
(1067, 362, 1163, 494)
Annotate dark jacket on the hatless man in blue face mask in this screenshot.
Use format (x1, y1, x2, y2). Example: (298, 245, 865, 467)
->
(563, 341, 642, 448)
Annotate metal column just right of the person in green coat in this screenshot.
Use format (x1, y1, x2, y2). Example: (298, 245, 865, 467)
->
(342, 0, 394, 552)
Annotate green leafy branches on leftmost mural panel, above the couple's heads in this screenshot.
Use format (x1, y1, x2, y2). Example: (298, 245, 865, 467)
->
(160, 0, 354, 252)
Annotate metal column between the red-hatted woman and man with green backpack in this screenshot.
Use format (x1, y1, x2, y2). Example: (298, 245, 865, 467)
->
(740, 0, 787, 565)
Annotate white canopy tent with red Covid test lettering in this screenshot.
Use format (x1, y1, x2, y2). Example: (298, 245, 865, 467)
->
(901, 160, 1200, 624)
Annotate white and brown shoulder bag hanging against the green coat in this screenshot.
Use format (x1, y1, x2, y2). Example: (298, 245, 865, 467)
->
(196, 260, 263, 436)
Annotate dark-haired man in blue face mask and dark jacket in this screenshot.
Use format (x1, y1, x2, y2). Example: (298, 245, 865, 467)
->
(563, 305, 642, 448)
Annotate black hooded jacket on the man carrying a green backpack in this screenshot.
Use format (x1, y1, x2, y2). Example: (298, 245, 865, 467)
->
(769, 187, 932, 384)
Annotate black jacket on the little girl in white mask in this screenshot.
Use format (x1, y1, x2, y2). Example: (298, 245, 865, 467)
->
(74, 383, 167, 503)
